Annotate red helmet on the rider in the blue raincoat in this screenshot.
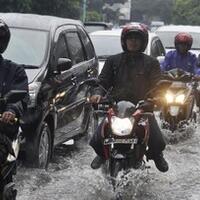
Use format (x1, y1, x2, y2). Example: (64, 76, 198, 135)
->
(174, 33, 193, 50)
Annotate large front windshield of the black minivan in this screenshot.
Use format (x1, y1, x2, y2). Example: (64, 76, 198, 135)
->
(3, 28, 48, 67)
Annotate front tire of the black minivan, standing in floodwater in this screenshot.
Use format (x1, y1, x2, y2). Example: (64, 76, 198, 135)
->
(26, 122, 52, 169)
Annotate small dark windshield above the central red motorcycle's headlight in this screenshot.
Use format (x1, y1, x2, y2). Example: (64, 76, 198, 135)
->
(114, 101, 135, 118)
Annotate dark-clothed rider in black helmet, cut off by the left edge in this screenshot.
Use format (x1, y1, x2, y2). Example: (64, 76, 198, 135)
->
(0, 20, 28, 165)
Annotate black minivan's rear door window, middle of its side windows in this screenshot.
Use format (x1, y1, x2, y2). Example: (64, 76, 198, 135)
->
(65, 32, 84, 65)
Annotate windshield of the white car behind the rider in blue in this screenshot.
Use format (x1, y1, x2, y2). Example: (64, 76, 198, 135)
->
(157, 31, 200, 49)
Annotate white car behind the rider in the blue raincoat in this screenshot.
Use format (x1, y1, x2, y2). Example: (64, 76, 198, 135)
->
(155, 25, 200, 56)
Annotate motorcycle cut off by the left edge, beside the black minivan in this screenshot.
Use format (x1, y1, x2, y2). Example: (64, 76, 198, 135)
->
(0, 90, 27, 200)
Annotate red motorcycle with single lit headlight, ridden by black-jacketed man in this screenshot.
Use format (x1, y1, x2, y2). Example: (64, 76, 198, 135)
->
(86, 77, 171, 190)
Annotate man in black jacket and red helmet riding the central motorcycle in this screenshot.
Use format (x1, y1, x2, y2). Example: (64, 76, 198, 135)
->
(90, 24, 168, 172)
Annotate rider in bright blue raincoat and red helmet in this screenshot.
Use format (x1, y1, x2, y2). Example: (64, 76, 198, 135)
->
(161, 32, 200, 75)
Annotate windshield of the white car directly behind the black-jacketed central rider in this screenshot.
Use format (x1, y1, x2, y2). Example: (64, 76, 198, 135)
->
(91, 35, 122, 58)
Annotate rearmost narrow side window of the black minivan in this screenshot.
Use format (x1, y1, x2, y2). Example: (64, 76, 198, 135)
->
(79, 27, 95, 60)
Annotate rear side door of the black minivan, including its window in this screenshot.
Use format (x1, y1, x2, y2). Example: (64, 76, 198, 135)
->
(56, 25, 96, 143)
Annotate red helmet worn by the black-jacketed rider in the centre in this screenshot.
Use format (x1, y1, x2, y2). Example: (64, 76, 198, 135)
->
(121, 24, 149, 52)
